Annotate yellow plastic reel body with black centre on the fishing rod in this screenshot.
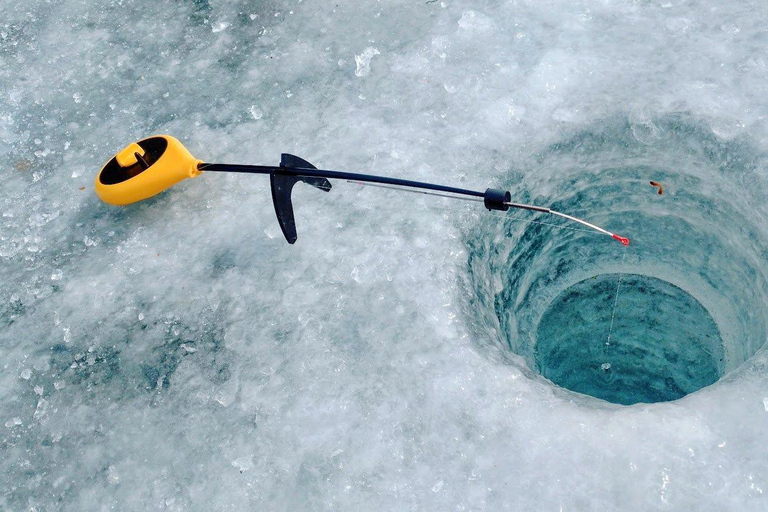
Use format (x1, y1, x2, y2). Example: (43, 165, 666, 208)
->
(95, 135, 202, 206)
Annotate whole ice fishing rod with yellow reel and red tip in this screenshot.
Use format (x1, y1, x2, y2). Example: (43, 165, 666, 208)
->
(95, 135, 629, 246)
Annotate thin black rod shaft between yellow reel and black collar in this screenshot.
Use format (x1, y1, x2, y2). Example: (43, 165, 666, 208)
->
(198, 163, 485, 197)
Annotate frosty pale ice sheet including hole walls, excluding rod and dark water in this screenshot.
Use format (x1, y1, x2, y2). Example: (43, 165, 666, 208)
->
(0, 0, 768, 511)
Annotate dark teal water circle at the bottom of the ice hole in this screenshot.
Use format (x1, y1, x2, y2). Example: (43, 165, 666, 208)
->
(534, 274, 724, 405)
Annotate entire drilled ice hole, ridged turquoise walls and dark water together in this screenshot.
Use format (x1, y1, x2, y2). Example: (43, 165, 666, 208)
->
(467, 115, 768, 405)
